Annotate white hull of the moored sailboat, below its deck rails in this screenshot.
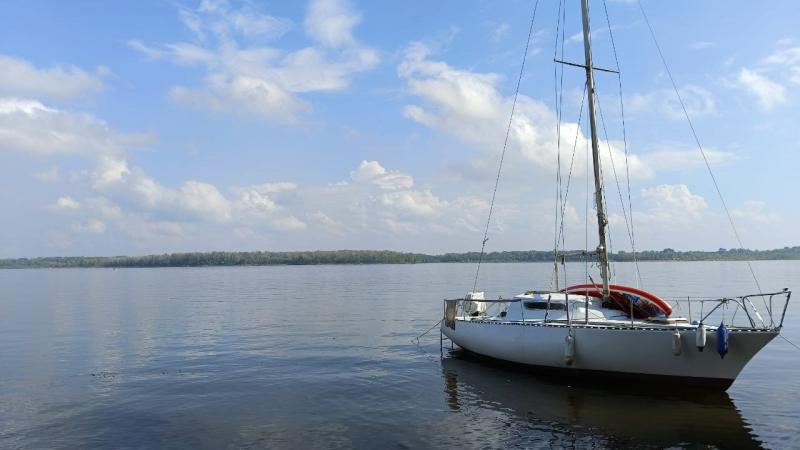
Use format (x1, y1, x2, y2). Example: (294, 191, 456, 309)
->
(442, 318, 778, 390)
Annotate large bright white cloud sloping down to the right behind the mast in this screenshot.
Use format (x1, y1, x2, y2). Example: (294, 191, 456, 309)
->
(398, 43, 654, 178)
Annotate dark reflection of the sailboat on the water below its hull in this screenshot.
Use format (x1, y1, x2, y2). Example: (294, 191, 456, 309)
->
(442, 350, 762, 448)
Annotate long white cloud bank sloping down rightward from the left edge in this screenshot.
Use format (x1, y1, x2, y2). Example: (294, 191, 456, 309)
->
(0, 95, 316, 236)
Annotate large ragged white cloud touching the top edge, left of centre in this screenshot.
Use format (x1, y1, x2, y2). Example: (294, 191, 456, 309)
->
(128, 0, 379, 123)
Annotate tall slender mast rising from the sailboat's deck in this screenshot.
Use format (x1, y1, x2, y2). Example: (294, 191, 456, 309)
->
(581, 0, 609, 298)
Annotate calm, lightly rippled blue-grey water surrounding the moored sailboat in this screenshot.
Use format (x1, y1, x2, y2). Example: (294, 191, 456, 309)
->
(0, 262, 800, 448)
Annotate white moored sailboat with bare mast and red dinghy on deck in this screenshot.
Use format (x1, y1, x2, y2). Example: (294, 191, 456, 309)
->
(441, 0, 791, 391)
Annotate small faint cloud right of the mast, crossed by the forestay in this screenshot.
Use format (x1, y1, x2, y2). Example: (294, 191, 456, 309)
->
(625, 85, 717, 120)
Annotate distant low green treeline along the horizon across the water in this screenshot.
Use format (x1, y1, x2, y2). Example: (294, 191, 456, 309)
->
(0, 247, 800, 269)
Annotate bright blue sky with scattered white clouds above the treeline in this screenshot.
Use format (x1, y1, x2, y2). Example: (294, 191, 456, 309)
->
(0, 0, 800, 257)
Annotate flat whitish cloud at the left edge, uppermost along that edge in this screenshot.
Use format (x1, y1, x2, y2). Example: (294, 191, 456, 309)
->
(0, 55, 108, 100)
